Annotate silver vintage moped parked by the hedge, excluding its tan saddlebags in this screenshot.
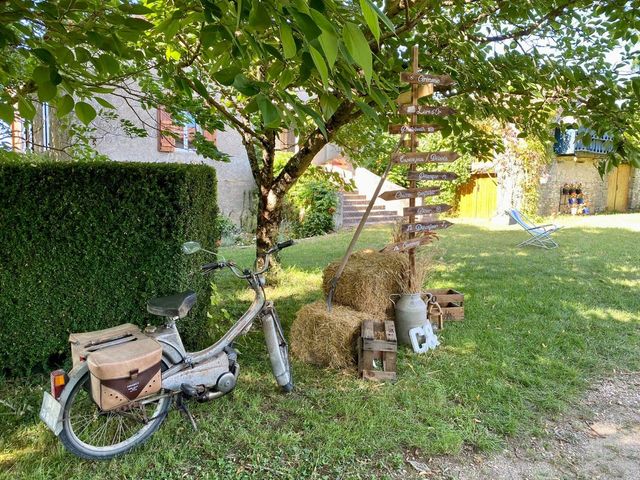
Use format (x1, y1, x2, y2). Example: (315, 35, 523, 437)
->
(40, 240, 293, 460)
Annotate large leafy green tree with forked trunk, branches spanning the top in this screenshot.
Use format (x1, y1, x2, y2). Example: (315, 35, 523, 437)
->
(0, 0, 640, 253)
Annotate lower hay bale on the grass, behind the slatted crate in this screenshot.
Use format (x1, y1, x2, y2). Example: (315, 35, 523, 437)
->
(290, 300, 372, 368)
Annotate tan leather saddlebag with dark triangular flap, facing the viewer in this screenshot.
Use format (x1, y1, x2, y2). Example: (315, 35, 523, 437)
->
(87, 334, 162, 410)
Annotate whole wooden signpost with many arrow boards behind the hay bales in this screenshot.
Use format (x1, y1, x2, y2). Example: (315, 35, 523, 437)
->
(380, 45, 459, 291)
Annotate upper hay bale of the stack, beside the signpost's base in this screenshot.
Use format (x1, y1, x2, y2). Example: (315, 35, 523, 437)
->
(322, 249, 409, 318)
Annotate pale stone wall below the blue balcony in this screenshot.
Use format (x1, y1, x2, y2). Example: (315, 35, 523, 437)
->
(538, 157, 608, 215)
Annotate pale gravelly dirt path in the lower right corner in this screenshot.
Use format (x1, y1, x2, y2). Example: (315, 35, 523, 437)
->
(405, 372, 640, 480)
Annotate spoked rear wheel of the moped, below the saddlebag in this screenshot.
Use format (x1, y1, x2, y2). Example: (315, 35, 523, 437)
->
(60, 371, 171, 460)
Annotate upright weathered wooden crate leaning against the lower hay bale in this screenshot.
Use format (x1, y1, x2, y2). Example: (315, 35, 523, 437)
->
(358, 320, 398, 381)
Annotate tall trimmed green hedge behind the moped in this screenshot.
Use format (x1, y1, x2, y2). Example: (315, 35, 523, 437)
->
(0, 161, 219, 374)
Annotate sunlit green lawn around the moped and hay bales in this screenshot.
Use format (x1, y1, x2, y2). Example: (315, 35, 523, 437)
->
(0, 215, 640, 479)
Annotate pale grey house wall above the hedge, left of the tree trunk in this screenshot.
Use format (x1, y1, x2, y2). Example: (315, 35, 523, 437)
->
(95, 96, 256, 224)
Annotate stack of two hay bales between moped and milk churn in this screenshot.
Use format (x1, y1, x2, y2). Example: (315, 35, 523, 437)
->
(291, 249, 409, 368)
